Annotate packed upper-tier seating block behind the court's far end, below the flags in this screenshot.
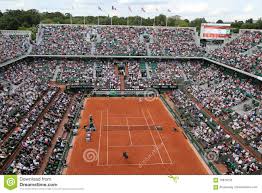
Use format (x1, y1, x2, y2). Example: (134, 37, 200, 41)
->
(33, 25, 203, 56)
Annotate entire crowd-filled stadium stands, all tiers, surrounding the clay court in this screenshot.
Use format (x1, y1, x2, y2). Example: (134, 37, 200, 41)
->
(0, 25, 262, 174)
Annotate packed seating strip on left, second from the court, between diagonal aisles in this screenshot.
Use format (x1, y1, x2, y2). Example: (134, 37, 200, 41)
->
(6, 93, 70, 174)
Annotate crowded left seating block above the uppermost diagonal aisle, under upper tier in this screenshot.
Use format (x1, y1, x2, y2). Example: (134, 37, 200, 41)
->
(0, 59, 54, 139)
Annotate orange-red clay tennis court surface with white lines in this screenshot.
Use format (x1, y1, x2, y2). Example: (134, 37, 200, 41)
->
(64, 97, 210, 174)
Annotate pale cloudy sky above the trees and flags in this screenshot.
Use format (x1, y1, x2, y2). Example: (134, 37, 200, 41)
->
(0, 0, 262, 21)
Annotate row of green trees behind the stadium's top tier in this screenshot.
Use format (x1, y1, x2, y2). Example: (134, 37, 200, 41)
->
(0, 9, 262, 32)
